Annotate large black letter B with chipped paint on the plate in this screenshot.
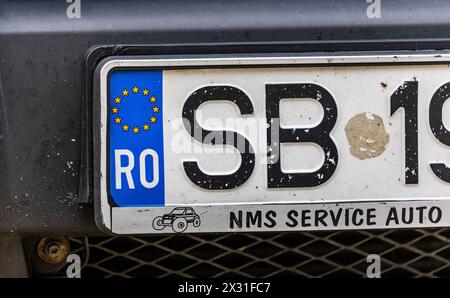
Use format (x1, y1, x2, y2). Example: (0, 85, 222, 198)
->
(266, 84, 338, 188)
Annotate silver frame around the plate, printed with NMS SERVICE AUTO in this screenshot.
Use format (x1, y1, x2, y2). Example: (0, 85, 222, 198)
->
(94, 51, 450, 234)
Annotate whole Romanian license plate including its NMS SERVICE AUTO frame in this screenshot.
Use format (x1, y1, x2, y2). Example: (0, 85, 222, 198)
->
(94, 53, 450, 234)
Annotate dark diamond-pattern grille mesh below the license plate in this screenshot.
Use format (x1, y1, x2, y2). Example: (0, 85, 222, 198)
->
(64, 229, 450, 278)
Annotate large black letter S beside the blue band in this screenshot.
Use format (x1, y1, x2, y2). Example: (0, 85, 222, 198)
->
(182, 86, 255, 189)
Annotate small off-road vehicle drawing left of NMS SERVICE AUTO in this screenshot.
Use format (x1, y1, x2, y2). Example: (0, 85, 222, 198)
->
(153, 207, 200, 233)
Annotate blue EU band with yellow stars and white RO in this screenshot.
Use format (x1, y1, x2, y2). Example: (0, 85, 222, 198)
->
(108, 70, 164, 207)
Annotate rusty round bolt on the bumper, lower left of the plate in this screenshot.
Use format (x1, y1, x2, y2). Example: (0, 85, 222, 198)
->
(37, 236, 70, 264)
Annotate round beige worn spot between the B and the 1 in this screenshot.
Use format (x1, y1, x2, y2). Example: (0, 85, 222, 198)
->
(345, 113, 389, 160)
